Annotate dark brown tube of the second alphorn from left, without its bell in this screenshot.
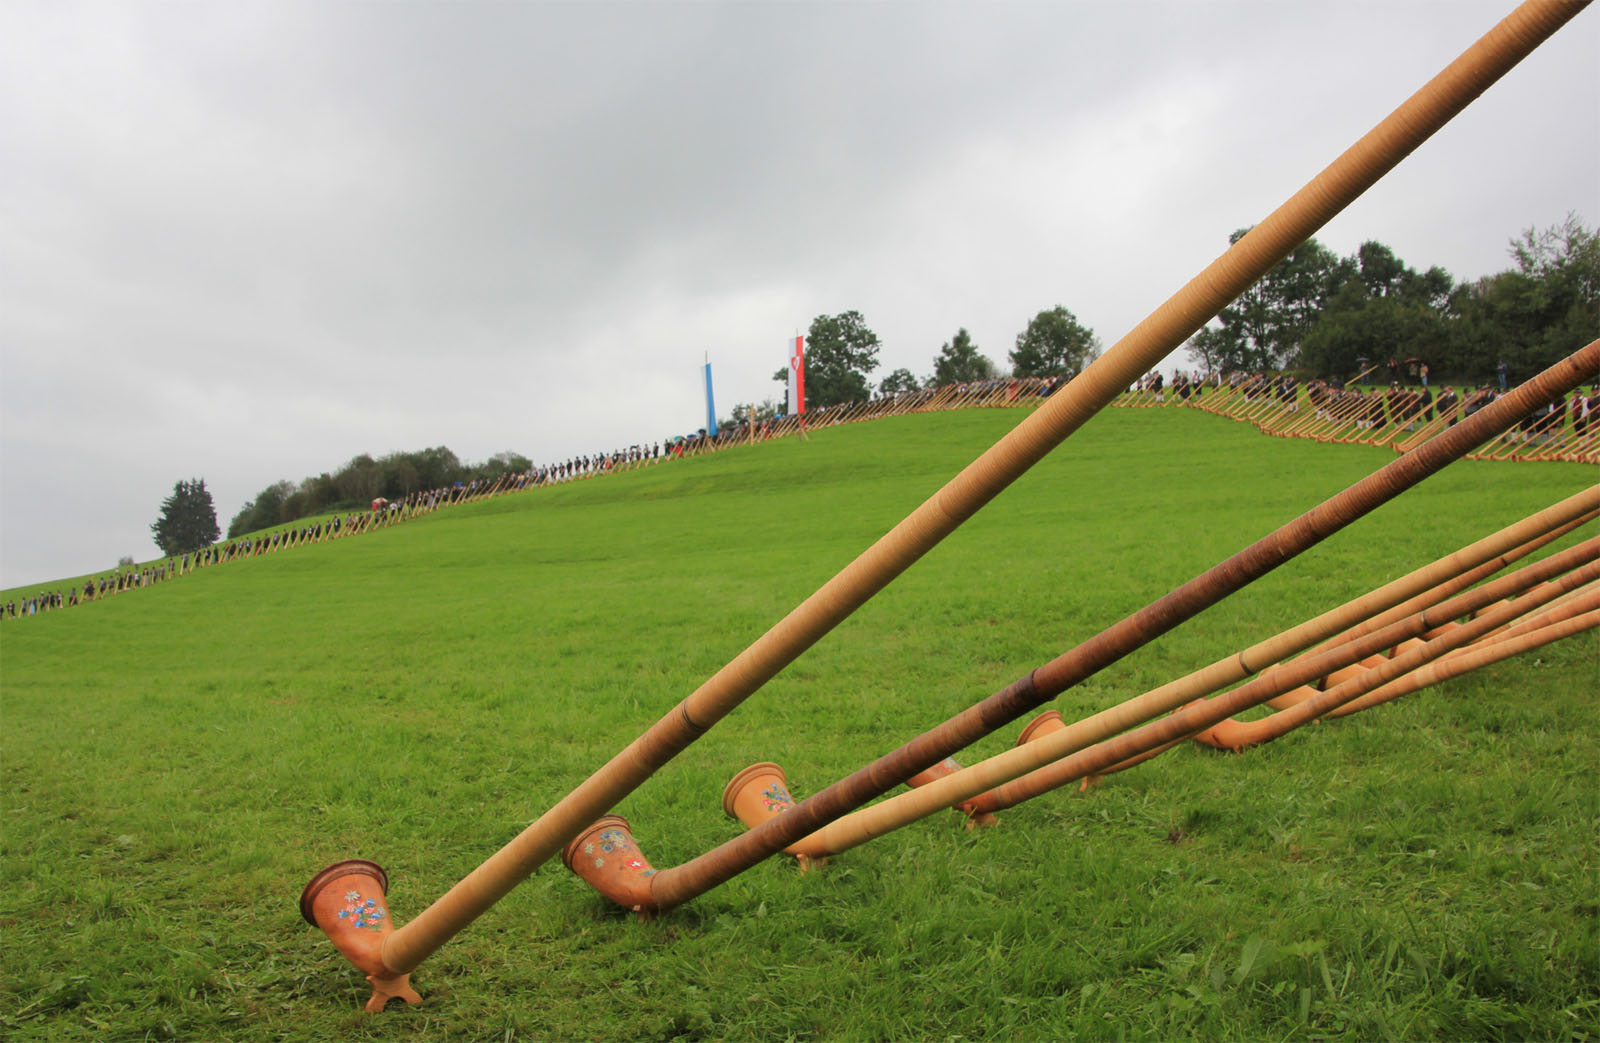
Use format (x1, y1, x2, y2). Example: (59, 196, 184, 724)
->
(620, 351, 1600, 909)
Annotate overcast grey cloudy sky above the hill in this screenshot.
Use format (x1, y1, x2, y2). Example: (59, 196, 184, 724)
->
(0, 0, 1600, 585)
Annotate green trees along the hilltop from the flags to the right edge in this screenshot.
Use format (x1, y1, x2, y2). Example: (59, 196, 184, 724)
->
(736, 214, 1600, 424)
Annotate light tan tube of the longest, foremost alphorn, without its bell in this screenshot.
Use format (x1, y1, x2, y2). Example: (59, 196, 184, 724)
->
(300, 0, 1594, 1011)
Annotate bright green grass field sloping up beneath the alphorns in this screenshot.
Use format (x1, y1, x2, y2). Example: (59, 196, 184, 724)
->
(0, 410, 1600, 1040)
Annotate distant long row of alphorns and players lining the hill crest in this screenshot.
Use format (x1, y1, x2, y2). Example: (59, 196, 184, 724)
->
(12, 373, 1600, 619)
